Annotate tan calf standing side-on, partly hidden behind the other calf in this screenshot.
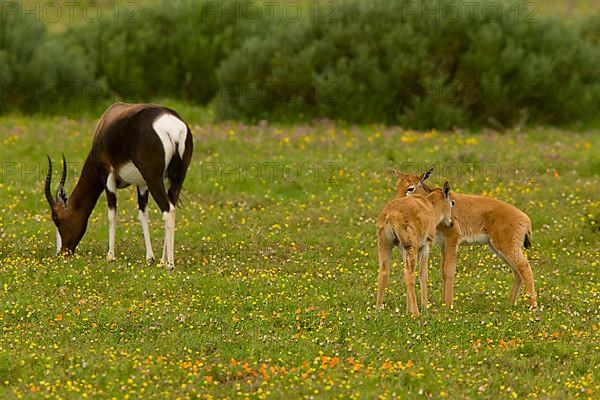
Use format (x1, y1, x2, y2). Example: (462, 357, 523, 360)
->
(394, 168, 536, 308)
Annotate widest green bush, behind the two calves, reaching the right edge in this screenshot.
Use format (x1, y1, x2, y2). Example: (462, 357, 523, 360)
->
(218, 0, 600, 128)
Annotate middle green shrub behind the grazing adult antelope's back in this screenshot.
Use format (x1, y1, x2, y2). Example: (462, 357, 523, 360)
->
(72, 0, 264, 104)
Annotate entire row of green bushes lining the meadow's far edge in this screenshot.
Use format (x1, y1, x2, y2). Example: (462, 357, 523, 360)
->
(0, 0, 600, 129)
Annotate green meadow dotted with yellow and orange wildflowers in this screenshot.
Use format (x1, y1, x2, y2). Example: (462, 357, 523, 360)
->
(0, 113, 600, 399)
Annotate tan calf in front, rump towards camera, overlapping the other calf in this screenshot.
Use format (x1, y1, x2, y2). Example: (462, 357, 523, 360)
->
(377, 182, 454, 315)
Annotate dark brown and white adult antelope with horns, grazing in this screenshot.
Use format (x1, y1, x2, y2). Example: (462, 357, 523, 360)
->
(45, 103, 193, 269)
